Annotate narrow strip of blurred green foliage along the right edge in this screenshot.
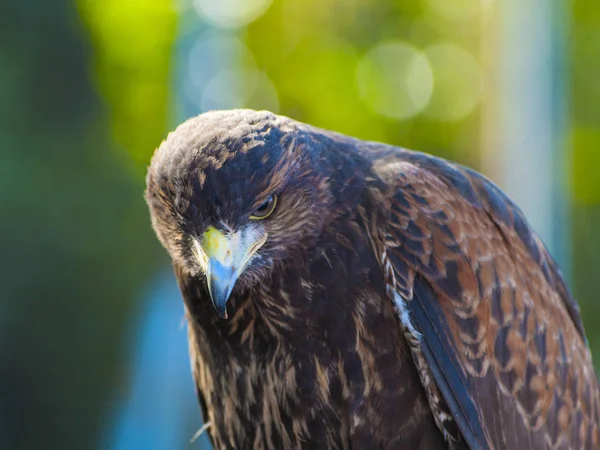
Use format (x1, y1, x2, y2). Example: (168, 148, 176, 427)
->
(569, 0, 600, 356)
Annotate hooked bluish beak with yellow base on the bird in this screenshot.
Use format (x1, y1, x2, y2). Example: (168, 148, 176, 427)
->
(196, 226, 267, 319)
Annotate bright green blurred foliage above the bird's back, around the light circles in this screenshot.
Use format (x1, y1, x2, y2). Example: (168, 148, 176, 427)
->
(245, 0, 480, 166)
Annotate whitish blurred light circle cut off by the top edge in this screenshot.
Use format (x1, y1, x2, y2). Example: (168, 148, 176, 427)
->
(193, 0, 272, 28)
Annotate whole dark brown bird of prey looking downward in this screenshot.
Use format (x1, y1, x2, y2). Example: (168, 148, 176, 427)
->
(146, 110, 600, 450)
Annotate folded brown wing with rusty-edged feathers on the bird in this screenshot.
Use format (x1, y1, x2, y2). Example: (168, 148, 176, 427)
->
(366, 151, 600, 449)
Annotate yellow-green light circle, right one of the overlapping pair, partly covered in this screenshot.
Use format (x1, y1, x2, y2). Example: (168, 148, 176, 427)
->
(424, 43, 482, 122)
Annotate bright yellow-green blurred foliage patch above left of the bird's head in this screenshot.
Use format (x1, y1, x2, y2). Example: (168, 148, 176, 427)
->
(77, 0, 177, 171)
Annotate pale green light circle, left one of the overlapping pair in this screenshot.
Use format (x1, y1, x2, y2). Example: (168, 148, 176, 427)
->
(356, 41, 433, 119)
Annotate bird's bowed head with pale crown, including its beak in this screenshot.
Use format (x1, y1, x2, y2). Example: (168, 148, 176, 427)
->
(146, 110, 352, 317)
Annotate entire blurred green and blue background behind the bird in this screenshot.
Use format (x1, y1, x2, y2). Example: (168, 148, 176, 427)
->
(0, 0, 600, 450)
